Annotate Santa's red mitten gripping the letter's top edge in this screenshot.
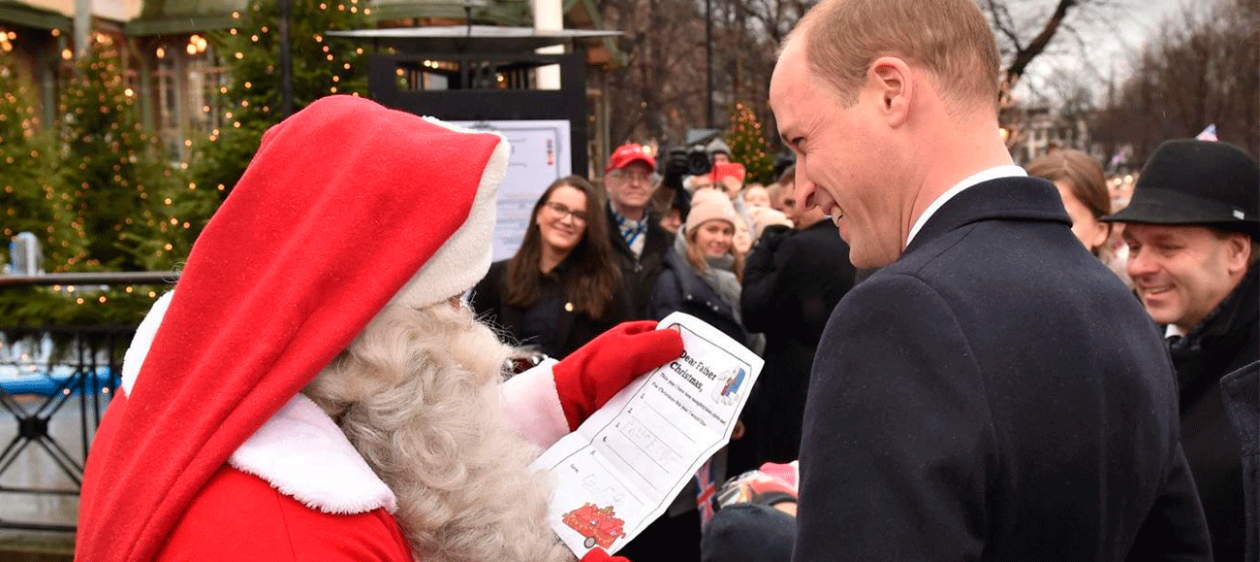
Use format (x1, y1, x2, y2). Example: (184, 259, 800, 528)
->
(552, 320, 683, 431)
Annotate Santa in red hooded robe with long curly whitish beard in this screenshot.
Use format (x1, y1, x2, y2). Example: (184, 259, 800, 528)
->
(76, 96, 682, 562)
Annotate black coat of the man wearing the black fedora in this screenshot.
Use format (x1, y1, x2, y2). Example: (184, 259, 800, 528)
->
(1169, 267, 1260, 562)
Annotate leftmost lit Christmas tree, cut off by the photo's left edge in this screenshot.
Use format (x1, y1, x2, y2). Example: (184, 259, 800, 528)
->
(0, 45, 86, 271)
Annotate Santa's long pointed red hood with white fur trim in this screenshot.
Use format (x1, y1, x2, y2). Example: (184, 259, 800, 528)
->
(76, 96, 509, 562)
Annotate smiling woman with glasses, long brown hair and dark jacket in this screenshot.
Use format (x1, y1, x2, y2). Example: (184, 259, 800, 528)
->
(471, 175, 631, 359)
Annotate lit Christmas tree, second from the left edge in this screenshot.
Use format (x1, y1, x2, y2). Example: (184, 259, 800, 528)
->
(59, 34, 181, 271)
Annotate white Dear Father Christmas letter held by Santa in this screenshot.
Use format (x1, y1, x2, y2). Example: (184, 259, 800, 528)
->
(534, 313, 764, 558)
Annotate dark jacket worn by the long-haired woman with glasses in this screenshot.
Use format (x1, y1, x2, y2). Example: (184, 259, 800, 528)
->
(470, 260, 631, 359)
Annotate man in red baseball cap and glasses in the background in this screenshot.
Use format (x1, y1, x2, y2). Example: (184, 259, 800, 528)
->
(604, 144, 672, 319)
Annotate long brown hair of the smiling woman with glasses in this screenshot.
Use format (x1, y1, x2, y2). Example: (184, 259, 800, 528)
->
(501, 175, 621, 320)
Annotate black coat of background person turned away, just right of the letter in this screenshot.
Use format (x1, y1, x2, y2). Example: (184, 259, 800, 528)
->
(728, 219, 856, 474)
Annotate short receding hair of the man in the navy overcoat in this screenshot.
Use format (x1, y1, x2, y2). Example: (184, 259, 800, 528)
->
(790, 0, 1000, 112)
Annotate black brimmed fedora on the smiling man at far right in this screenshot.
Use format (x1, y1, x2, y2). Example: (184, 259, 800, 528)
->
(1103, 139, 1260, 237)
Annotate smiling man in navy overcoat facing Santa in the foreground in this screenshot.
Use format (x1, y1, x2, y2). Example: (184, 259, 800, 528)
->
(770, 0, 1211, 561)
